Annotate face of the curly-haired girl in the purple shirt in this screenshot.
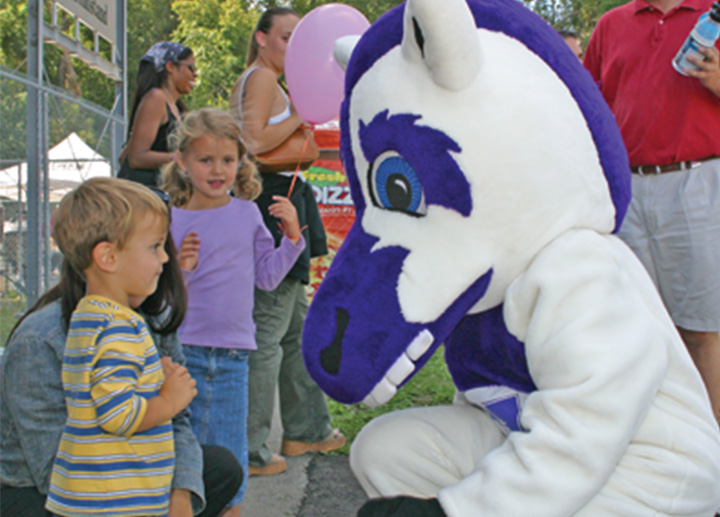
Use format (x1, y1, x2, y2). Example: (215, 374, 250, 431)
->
(178, 134, 240, 210)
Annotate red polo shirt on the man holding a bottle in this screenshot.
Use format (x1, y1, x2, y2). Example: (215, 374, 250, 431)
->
(585, 0, 720, 166)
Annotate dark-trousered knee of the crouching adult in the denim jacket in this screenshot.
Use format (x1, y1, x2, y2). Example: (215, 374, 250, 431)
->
(198, 445, 244, 517)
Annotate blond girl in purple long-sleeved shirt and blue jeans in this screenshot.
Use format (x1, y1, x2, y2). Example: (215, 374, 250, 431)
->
(164, 108, 305, 516)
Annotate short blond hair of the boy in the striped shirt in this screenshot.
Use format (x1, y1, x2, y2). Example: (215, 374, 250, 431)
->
(53, 178, 168, 276)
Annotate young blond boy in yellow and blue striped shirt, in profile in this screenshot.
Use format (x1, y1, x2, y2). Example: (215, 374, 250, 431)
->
(45, 178, 197, 517)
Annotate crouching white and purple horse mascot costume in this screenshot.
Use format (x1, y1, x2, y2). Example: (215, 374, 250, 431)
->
(304, 0, 720, 517)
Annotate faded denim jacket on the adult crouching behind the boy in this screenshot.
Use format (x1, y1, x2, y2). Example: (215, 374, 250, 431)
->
(0, 302, 205, 515)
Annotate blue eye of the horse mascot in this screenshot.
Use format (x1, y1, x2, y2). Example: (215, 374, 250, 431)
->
(369, 152, 427, 217)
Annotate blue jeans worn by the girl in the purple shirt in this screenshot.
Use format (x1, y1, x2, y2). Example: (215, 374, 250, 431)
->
(185, 345, 249, 506)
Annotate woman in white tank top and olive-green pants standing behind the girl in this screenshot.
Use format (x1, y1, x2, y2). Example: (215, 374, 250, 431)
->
(231, 7, 345, 476)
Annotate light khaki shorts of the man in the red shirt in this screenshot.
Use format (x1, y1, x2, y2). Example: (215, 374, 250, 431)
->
(618, 159, 720, 332)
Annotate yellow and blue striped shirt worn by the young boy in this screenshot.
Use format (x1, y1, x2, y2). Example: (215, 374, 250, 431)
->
(46, 296, 175, 517)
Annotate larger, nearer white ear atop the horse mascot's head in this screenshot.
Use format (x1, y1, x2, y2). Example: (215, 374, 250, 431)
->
(402, 0, 481, 91)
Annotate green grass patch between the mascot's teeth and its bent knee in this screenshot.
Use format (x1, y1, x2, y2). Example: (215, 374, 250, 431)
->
(328, 347, 455, 455)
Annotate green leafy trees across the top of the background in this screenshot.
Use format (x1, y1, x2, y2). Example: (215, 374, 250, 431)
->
(0, 0, 626, 157)
